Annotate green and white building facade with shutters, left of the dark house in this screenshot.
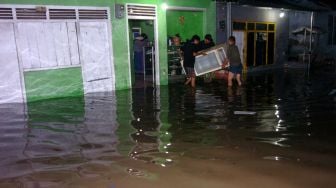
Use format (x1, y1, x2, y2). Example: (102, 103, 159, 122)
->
(0, 0, 216, 103)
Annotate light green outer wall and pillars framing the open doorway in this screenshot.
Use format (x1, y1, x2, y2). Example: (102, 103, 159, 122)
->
(0, 0, 216, 99)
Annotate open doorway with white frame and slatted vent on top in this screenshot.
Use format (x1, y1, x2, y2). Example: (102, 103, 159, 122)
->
(127, 4, 160, 88)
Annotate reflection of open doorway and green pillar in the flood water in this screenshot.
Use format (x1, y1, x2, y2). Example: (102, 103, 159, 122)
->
(129, 88, 172, 167)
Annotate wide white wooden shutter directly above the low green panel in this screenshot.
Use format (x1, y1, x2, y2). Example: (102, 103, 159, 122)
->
(16, 22, 80, 70)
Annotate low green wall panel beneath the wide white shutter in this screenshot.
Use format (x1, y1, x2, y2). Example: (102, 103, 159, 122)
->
(24, 67, 84, 102)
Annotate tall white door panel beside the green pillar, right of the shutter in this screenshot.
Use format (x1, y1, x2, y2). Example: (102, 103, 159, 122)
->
(78, 22, 114, 93)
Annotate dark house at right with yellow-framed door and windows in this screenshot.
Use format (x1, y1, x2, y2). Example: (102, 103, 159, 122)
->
(216, 0, 336, 70)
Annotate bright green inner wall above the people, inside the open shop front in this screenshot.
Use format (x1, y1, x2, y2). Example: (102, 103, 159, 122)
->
(167, 10, 205, 41)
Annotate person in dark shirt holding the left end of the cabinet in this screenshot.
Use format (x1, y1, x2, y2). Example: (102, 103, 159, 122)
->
(181, 35, 201, 87)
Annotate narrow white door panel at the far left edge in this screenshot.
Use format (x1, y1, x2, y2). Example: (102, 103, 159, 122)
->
(0, 23, 24, 103)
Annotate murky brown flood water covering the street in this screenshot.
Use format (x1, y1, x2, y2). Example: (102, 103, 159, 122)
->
(0, 70, 336, 188)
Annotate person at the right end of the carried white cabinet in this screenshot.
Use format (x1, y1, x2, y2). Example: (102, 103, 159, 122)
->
(227, 36, 243, 87)
